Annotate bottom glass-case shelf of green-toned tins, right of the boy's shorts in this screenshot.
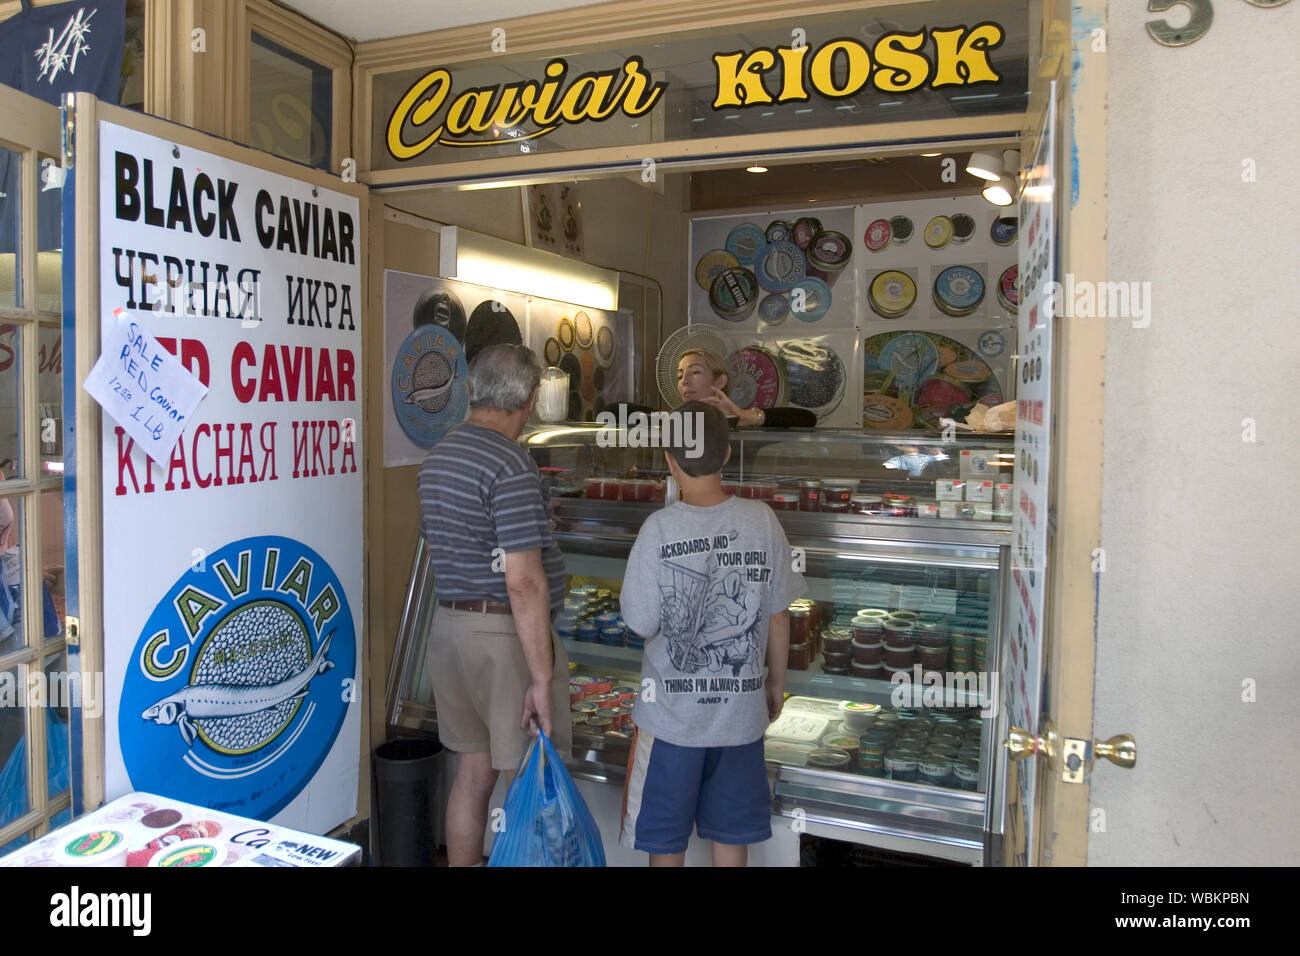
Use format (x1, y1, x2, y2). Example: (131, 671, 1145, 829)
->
(807, 701, 984, 791)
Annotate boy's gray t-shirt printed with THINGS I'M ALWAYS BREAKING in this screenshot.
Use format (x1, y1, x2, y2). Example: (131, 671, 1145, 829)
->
(619, 497, 806, 747)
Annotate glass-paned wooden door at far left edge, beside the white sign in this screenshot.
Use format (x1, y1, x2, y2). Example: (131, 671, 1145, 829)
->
(0, 86, 72, 856)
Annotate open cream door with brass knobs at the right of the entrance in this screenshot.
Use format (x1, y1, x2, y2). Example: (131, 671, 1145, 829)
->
(1002, 0, 1136, 866)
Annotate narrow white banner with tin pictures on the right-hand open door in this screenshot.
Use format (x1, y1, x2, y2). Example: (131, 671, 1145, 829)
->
(1002, 85, 1056, 862)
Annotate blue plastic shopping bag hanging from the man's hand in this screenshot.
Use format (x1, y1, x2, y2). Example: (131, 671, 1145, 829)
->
(488, 732, 605, 866)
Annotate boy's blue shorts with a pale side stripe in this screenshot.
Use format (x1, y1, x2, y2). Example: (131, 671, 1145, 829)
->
(619, 731, 772, 853)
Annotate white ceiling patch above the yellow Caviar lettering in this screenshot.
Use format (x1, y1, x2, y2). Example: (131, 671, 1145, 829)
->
(280, 0, 603, 42)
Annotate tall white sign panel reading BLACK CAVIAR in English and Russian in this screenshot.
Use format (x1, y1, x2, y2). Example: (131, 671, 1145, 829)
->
(99, 124, 363, 832)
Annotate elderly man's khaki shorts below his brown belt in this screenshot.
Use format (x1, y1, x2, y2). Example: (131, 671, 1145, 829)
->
(425, 605, 573, 770)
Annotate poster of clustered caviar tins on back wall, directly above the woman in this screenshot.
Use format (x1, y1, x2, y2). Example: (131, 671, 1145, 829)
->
(688, 207, 855, 334)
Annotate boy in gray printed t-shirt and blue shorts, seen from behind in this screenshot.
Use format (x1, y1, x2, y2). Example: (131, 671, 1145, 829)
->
(619, 402, 805, 866)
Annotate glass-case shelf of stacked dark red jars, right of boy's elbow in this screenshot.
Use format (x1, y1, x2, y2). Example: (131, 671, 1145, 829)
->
(787, 598, 988, 680)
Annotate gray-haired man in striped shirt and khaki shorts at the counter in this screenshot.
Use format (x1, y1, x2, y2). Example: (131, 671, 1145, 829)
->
(420, 345, 572, 866)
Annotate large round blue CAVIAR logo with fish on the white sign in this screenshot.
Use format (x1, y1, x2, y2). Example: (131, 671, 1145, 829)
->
(117, 535, 360, 819)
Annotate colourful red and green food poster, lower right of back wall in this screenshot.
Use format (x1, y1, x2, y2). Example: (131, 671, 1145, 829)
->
(862, 328, 1011, 431)
